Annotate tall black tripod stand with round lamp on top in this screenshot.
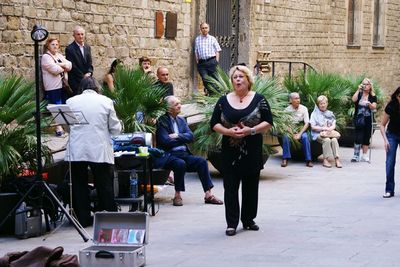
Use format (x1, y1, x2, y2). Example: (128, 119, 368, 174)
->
(0, 25, 89, 242)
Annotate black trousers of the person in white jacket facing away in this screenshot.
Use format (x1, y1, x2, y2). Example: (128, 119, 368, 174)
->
(71, 161, 117, 226)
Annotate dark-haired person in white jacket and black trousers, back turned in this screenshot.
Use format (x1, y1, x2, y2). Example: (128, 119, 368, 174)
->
(65, 76, 122, 227)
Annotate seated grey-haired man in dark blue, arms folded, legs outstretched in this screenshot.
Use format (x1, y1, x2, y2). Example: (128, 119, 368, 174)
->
(156, 96, 223, 206)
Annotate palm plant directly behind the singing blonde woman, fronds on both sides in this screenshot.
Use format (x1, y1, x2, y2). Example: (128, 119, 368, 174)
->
(193, 68, 293, 158)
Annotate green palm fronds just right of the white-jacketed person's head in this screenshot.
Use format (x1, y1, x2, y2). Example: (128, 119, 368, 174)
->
(103, 66, 166, 132)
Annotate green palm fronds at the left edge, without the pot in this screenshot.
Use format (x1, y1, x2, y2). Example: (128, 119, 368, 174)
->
(0, 76, 51, 185)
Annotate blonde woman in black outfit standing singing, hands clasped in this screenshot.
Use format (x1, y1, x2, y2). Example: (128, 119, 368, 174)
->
(210, 66, 272, 236)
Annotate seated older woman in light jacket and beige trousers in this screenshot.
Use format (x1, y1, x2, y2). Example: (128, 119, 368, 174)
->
(310, 95, 342, 168)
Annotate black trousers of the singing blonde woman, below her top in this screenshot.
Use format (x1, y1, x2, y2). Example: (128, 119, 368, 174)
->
(224, 169, 260, 229)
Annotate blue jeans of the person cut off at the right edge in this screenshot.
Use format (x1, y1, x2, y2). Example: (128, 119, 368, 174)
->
(385, 132, 400, 193)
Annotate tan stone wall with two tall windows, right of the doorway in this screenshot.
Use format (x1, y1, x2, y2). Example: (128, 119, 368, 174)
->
(248, 0, 400, 96)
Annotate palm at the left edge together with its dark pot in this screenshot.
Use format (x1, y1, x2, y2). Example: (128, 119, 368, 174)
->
(0, 76, 51, 234)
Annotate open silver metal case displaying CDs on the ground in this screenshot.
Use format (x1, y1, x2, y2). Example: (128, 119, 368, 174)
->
(79, 212, 149, 267)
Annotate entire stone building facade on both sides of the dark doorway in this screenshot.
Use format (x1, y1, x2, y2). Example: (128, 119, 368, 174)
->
(0, 0, 400, 97)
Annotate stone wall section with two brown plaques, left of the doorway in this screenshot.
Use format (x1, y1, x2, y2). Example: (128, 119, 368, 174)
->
(0, 0, 193, 96)
